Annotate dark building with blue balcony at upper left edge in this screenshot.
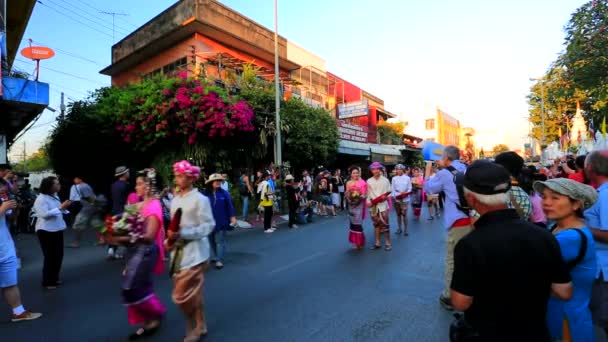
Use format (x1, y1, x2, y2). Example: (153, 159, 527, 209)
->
(0, 0, 49, 164)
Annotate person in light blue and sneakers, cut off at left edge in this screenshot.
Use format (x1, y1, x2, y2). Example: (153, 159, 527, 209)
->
(0, 178, 42, 322)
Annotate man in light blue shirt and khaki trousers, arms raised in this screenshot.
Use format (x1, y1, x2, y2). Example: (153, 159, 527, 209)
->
(424, 146, 472, 310)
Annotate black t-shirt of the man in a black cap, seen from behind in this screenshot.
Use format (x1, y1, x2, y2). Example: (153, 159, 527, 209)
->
(451, 209, 571, 342)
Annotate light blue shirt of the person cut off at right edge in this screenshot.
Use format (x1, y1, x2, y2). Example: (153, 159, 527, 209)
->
(585, 183, 608, 281)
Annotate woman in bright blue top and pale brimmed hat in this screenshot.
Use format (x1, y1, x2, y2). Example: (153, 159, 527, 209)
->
(534, 178, 597, 342)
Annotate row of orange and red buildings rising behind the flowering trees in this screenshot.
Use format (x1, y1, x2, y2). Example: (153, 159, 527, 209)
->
(101, 0, 401, 162)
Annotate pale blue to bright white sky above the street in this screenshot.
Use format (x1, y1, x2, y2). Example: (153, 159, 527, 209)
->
(9, 0, 584, 159)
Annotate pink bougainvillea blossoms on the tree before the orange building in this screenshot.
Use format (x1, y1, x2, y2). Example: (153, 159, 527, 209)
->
(116, 73, 254, 148)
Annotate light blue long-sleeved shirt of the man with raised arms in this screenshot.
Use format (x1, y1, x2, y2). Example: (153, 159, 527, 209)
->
(424, 160, 468, 229)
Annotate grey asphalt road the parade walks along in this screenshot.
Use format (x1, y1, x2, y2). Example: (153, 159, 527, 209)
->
(0, 210, 452, 342)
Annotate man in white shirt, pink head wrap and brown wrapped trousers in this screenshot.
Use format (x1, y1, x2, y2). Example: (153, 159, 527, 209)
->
(165, 160, 215, 342)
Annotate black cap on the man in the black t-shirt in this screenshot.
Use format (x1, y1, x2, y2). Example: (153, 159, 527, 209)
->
(463, 160, 511, 195)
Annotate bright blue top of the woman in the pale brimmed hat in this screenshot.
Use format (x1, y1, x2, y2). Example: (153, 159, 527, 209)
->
(547, 228, 597, 342)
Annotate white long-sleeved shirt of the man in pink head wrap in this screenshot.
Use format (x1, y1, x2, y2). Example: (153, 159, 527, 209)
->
(171, 188, 215, 270)
